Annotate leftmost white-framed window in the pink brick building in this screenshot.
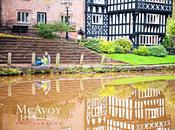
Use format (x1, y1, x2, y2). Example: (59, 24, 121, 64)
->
(17, 12, 29, 23)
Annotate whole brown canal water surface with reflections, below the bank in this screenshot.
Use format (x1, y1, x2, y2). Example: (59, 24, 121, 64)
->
(0, 72, 175, 130)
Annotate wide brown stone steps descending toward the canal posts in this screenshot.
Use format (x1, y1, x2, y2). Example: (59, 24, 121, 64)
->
(0, 38, 123, 64)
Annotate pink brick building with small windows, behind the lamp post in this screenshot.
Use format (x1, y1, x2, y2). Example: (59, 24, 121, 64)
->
(0, 0, 84, 29)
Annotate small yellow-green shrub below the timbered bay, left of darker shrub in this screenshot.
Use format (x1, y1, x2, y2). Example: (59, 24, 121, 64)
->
(133, 46, 150, 56)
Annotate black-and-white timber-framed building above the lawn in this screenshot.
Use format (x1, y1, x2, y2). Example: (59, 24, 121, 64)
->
(85, 0, 173, 46)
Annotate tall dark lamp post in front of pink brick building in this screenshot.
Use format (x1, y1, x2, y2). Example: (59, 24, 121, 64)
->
(63, 0, 72, 39)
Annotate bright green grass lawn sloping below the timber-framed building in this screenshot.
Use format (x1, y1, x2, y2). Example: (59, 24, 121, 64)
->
(107, 54, 175, 65)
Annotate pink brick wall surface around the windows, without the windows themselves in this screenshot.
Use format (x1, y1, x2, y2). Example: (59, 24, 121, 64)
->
(1, 0, 84, 29)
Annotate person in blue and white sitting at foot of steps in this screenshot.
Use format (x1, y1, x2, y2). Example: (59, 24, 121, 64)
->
(35, 51, 51, 66)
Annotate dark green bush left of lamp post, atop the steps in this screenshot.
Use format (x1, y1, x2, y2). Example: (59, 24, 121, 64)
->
(38, 24, 56, 39)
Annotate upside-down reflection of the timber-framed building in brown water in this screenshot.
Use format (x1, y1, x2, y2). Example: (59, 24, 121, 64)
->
(86, 89, 171, 130)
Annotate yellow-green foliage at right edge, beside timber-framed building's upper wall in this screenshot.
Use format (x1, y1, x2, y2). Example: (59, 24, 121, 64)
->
(167, 19, 175, 35)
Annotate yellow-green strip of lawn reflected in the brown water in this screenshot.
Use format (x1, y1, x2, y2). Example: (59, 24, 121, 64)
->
(109, 75, 175, 85)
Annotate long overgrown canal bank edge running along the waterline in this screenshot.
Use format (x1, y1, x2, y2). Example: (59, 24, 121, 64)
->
(0, 64, 175, 76)
